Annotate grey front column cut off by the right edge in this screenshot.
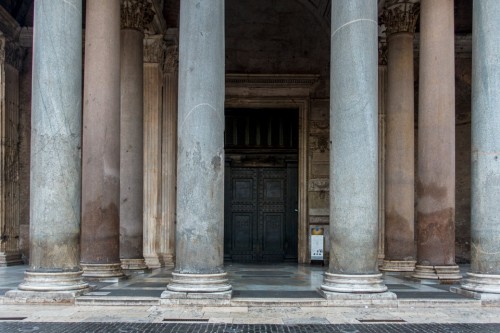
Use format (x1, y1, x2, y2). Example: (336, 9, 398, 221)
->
(461, 0, 500, 302)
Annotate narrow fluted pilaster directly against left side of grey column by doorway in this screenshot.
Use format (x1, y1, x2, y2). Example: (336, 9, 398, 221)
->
(159, 45, 179, 267)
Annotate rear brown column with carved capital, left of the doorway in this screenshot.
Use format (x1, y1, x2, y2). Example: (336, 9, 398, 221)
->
(120, 0, 154, 269)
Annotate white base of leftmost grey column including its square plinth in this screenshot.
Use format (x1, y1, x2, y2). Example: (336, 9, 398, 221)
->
(4, 271, 91, 304)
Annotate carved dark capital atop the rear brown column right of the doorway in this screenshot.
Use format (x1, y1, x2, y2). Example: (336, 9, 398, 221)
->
(380, 0, 420, 36)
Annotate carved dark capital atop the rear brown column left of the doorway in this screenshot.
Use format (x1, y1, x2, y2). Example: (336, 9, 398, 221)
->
(121, 0, 155, 32)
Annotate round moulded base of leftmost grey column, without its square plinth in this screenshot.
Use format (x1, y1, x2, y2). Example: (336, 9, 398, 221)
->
(18, 271, 89, 292)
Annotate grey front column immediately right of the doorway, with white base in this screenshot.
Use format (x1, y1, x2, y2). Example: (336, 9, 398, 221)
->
(321, 0, 393, 299)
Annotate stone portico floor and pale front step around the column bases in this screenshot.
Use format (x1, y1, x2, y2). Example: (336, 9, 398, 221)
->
(0, 264, 500, 324)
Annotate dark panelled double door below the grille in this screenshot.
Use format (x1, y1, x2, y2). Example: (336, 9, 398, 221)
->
(224, 164, 297, 262)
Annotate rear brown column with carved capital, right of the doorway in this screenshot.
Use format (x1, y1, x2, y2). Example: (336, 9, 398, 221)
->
(381, 0, 420, 272)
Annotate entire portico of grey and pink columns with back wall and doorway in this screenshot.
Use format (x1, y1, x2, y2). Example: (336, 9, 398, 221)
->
(0, 0, 500, 304)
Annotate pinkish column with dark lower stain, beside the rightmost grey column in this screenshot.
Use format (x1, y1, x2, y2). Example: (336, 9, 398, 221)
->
(413, 0, 460, 280)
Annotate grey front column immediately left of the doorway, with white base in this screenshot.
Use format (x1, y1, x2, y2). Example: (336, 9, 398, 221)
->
(162, 0, 231, 298)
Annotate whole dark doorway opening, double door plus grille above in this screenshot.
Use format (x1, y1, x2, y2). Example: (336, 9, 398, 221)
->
(224, 109, 298, 262)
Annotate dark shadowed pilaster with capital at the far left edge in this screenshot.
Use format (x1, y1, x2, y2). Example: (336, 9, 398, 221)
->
(0, 36, 24, 267)
